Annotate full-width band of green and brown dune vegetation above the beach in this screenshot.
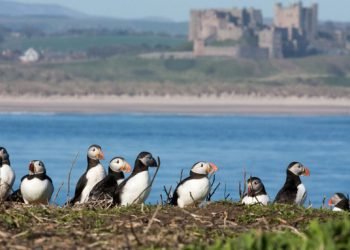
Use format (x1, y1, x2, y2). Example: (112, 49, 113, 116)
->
(0, 55, 350, 97)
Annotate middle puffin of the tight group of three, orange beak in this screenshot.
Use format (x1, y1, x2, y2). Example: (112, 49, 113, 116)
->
(89, 157, 131, 201)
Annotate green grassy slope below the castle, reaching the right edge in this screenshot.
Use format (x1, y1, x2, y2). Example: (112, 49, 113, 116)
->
(42, 56, 350, 86)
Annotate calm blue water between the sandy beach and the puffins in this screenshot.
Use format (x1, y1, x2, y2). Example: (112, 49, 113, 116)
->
(0, 114, 350, 207)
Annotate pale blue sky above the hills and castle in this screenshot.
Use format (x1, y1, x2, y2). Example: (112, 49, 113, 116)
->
(10, 0, 350, 22)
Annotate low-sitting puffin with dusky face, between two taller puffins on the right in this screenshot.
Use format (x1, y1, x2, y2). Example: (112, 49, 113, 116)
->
(242, 177, 270, 206)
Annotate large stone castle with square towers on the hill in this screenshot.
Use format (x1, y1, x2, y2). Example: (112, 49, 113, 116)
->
(189, 2, 318, 58)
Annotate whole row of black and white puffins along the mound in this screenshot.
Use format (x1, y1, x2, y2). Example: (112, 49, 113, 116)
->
(0, 145, 349, 211)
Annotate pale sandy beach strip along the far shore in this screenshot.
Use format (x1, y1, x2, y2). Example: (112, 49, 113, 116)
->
(0, 95, 350, 115)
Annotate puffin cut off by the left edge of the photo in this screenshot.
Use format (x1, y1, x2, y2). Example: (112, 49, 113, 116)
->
(0, 147, 16, 201)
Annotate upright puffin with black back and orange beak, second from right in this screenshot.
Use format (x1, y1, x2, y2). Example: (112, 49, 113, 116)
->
(274, 162, 310, 205)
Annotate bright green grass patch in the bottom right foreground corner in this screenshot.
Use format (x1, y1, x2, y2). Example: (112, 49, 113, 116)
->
(185, 217, 350, 250)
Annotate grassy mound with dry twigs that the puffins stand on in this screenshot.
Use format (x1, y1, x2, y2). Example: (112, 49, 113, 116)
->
(0, 202, 350, 249)
